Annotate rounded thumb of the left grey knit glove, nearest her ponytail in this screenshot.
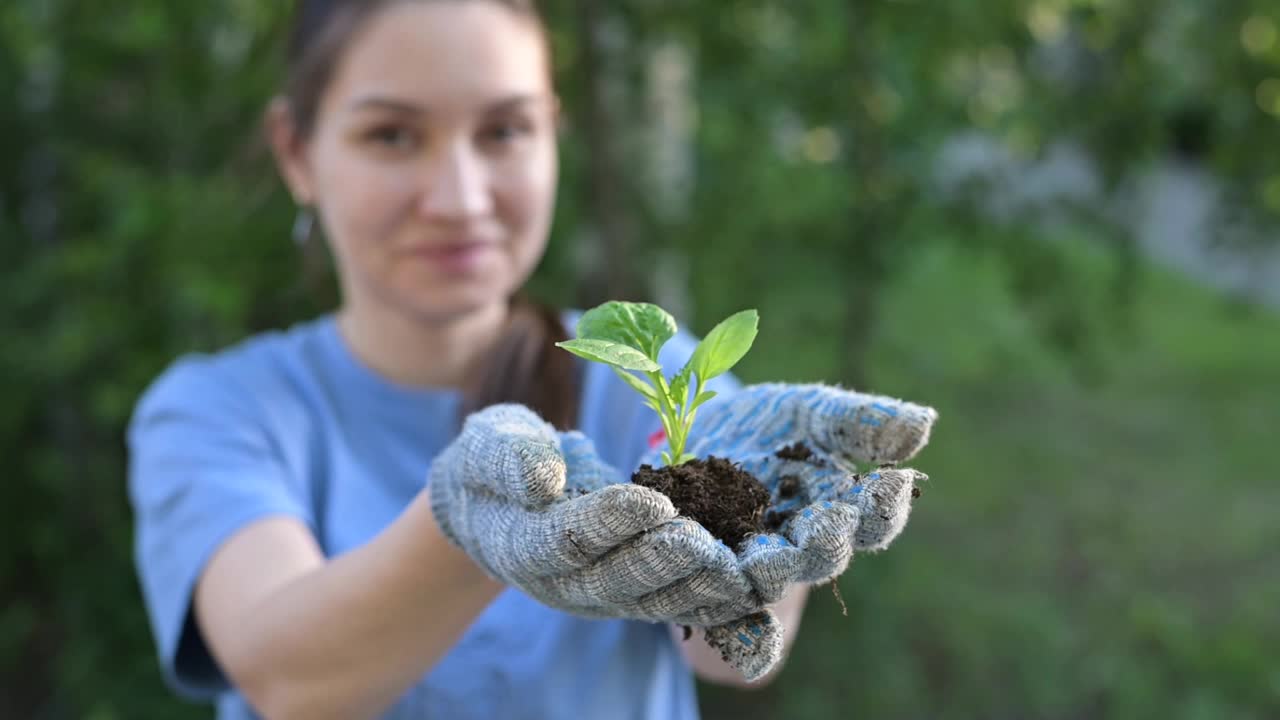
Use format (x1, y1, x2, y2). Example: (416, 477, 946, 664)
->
(453, 404, 564, 507)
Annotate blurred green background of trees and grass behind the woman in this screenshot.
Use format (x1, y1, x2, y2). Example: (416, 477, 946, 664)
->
(0, 0, 1280, 720)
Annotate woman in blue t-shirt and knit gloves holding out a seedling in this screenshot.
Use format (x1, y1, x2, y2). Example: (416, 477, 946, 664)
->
(129, 0, 936, 720)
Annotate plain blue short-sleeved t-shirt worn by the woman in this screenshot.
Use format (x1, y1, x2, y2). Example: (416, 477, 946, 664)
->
(128, 311, 737, 720)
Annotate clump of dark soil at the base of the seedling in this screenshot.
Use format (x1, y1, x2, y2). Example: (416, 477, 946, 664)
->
(631, 456, 769, 550)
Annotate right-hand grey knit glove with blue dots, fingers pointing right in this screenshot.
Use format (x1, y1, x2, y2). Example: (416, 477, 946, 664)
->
(689, 383, 937, 673)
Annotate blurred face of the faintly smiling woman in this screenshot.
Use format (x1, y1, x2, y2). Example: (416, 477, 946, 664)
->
(294, 1, 557, 319)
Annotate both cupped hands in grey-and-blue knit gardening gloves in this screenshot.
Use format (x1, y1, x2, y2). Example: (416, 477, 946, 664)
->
(429, 384, 937, 680)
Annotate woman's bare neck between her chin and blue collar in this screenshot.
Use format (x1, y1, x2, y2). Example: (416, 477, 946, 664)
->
(338, 295, 508, 388)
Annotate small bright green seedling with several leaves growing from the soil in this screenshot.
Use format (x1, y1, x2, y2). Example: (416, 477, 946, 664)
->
(556, 301, 759, 465)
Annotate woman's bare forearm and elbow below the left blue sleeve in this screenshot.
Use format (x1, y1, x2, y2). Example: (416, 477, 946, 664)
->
(195, 492, 503, 720)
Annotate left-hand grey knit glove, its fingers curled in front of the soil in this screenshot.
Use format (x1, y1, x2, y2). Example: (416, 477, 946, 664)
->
(428, 405, 751, 625)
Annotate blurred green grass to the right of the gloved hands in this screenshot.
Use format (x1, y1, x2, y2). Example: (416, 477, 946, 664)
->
(703, 235, 1280, 720)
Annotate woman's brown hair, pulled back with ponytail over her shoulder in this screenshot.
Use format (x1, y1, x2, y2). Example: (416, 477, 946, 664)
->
(284, 0, 580, 429)
